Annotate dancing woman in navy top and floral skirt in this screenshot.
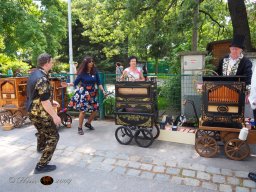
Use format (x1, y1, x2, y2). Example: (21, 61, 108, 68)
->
(64, 57, 106, 135)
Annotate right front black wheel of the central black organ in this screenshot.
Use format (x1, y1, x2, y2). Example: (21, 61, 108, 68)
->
(134, 128, 154, 147)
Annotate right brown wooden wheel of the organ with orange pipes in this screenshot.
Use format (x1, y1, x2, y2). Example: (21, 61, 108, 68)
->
(224, 139, 250, 161)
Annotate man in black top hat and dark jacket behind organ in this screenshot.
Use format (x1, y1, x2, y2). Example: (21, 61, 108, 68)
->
(217, 35, 252, 88)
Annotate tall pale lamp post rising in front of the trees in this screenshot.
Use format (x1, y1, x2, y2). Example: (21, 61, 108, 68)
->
(68, 0, 74, 83)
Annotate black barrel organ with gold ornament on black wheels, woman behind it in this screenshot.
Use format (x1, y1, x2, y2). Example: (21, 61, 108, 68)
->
(115, 78, 160, 147)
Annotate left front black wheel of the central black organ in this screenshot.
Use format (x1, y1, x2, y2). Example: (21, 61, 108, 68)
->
(115, 126, 133, 145)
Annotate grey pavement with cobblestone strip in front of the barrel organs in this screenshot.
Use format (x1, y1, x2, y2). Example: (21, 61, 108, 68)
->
(0, 119, 256, 192)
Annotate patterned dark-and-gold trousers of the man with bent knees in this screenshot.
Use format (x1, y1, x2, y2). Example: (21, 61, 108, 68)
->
(29, 114, 59, 166)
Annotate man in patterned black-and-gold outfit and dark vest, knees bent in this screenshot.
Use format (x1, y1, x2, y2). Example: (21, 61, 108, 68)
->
(26, 53, 61, 174)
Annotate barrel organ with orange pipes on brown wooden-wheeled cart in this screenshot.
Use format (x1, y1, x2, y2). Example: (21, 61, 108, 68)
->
(195, 76, 256, 160)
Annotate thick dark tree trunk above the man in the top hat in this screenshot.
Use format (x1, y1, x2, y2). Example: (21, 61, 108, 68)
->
(228, 0, 253, 51)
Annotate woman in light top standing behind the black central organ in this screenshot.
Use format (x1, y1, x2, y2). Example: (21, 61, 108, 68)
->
(121, 56, 145, 81)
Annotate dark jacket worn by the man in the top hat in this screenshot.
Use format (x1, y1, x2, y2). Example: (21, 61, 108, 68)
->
(217, 56, 252, 85)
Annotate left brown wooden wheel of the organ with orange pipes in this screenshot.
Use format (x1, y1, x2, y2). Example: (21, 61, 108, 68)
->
(195, 135, 218, 157)
